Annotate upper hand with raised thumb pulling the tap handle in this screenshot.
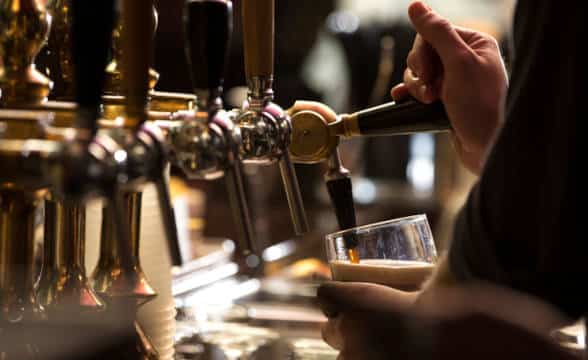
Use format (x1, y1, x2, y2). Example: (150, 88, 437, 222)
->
(392, 1, 508, 174)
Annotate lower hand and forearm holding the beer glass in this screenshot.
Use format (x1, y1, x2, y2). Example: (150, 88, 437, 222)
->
(317, 282, 570, 360)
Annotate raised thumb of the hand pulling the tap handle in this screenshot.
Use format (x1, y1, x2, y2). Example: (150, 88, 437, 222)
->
(408, 1, 467, 65)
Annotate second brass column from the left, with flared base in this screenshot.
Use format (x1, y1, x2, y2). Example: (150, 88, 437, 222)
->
(31, 0, 105, 320)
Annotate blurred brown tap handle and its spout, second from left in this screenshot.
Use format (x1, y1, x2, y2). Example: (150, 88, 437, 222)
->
(122, 0, 182, 265)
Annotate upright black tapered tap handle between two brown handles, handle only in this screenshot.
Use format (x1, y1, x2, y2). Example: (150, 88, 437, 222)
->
(184, 0, 233, 100)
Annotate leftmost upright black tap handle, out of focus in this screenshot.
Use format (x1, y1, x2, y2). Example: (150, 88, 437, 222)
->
(71, 0, 114, 135)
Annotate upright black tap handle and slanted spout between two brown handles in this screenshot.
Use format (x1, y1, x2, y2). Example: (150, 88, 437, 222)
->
(184, 0, 256, 252)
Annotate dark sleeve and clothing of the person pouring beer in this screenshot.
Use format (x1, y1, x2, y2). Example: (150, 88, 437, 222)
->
(449, 0, 588, 317)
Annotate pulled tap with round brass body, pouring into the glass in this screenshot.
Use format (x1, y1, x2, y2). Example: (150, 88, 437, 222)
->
(290, 99, 450, 256)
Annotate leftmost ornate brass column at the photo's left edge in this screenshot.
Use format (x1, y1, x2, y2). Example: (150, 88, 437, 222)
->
(0, 0, 58, 359)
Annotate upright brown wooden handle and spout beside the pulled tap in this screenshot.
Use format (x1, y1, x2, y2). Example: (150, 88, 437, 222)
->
(242, 0, 308, 235)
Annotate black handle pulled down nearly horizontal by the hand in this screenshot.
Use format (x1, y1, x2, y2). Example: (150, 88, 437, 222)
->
(352, 98, 451, 136)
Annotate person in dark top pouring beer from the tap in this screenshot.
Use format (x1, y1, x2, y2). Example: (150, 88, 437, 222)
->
(294, 0, 588, 360)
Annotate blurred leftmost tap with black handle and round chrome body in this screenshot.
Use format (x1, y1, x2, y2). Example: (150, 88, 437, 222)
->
(48, 0, 130, 268)
